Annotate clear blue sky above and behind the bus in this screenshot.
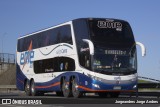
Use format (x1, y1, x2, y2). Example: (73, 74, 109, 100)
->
(0, 0, 160, 80)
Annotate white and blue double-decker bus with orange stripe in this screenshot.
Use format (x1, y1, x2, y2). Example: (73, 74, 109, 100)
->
(16, 18, 145, 98)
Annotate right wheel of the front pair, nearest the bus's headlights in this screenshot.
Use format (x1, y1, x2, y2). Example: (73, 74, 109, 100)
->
(72, 78, 82, 98)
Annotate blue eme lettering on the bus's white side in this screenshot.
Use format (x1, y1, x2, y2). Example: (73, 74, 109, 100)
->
(20, 50, 34, 65)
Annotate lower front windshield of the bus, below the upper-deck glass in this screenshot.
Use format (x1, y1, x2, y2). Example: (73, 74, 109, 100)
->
(93, 47, 137, 74)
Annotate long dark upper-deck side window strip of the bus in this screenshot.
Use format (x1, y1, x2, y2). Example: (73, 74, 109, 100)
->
(17, 25, 73, 52)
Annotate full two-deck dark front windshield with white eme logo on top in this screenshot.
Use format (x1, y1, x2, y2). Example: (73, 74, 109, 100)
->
(88, 19, 137, 74)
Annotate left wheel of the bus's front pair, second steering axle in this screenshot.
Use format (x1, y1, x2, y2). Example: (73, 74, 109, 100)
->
(62, 79, 71, 97)
